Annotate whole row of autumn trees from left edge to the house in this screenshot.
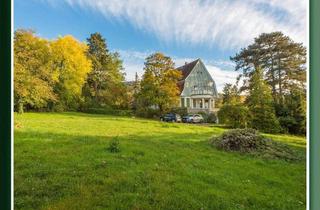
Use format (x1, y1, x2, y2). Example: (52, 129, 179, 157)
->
(14, 30, 181, 117)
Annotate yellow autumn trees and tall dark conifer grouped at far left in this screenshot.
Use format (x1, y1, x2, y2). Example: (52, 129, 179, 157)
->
(14, 30, 129, 113)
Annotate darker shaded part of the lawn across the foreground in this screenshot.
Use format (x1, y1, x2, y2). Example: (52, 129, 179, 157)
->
(14, 130, 305, 209)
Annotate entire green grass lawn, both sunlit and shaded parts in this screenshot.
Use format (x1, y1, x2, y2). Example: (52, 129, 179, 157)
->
(14, 113, 306, 210)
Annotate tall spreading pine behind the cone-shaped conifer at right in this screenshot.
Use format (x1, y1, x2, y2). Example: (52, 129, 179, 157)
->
(231, 32, 306, 134)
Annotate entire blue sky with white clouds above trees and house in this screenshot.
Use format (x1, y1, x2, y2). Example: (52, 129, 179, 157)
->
(14, 0, 307, 92)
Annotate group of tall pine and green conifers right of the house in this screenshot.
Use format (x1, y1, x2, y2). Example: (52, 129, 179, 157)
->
(218, 32, 306, 134)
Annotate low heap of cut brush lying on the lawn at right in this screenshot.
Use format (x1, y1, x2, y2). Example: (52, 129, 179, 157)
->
(210, 129, 303, 161)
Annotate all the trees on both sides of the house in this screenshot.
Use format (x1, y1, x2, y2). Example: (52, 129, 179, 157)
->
(14, 30, 306, 134)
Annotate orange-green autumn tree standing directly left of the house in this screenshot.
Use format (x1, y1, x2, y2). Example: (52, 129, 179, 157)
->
(138, 52, 182, 113)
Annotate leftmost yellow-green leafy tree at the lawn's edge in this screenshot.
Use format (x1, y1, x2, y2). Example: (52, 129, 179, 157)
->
(14, 30, 57, 113)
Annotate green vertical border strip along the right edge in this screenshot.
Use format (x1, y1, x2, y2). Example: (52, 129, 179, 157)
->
(309, 0, 320, 210)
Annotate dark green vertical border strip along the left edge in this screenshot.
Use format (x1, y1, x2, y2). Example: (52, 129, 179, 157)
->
(0, 0, 12, 210)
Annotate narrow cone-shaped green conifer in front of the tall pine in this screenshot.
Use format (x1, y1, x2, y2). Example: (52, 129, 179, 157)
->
(246, 68, 280, 133)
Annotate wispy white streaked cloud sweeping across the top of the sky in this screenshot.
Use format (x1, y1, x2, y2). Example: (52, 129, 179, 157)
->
(50, 0, 307, 49)
